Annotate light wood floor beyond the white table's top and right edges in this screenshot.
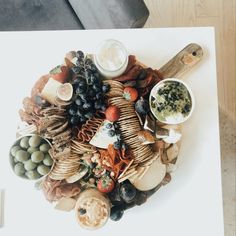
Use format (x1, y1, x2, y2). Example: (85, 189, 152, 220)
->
(144, 0, 236, 121)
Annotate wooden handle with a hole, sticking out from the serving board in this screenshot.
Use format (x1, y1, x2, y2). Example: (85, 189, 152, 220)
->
(159, 43, 203, 79)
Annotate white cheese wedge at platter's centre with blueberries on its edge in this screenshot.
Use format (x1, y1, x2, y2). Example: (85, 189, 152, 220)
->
(89, 120, 117, 149)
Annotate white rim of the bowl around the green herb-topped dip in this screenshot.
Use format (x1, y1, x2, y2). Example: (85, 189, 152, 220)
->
(149, 78, 195, 125)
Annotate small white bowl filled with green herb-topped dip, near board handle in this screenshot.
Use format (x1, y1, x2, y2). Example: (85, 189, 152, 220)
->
(149, 78, 195, 125)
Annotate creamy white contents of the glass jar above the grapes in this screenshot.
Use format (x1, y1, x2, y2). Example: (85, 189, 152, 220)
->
(97, 41, 127, 71)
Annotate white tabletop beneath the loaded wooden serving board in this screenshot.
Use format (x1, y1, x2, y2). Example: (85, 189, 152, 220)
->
(0, 28, 223, 236)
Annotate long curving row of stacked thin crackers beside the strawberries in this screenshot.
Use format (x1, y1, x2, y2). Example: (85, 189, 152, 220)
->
(105, 80, 159, 182)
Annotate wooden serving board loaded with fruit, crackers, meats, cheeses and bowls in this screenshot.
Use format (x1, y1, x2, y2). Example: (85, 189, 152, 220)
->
(10, 39, 203, 230)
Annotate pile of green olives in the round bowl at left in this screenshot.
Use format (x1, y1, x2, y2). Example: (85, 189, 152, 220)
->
(10, 135, 53, 179)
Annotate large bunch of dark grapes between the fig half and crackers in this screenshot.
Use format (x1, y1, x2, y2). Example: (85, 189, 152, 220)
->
(68, 51, 110, 126)
